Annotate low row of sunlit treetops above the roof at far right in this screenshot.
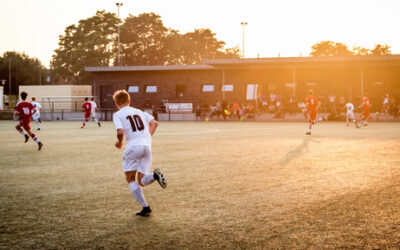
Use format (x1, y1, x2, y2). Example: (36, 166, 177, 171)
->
(310, 41, 391, 57)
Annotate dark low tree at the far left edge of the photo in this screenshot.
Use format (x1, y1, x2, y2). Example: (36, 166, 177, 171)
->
(0, 51, 47, 95)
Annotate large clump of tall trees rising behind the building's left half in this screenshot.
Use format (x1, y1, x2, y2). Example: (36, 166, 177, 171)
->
(52, 11, 239, 78)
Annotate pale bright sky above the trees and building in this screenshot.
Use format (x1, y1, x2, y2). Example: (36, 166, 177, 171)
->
(0, 0, 400, 67)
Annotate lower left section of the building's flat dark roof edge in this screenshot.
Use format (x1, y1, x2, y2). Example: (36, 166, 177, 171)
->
(85, 64, 214, 72)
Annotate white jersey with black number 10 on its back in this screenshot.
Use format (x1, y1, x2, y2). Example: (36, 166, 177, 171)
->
(113, 106, 154, 150)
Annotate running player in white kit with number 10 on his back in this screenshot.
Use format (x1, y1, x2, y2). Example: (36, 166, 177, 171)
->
(113, 90, 167, 216)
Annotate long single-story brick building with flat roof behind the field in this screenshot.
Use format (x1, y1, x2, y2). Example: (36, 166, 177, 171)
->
(85, 55, 400, 112)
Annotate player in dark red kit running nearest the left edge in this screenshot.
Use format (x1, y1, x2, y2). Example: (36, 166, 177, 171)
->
(14, 91, 43, 150)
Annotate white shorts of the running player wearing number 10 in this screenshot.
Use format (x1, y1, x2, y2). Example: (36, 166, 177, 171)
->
(122, 145, 151, 174)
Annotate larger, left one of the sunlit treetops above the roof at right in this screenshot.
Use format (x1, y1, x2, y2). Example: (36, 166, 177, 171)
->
(310, 41, 353, 57)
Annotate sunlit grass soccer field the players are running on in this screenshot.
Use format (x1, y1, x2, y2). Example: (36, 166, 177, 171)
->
(0, 121, 400, 249)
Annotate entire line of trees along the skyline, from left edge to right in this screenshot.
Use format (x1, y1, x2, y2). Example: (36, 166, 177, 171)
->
(0, 11, 391, 94)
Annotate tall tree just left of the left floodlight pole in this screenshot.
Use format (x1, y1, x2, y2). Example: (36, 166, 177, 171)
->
(52, 10, 120, 84)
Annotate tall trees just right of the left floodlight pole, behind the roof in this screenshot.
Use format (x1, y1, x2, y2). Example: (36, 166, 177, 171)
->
(121, 13, 239, 65)
